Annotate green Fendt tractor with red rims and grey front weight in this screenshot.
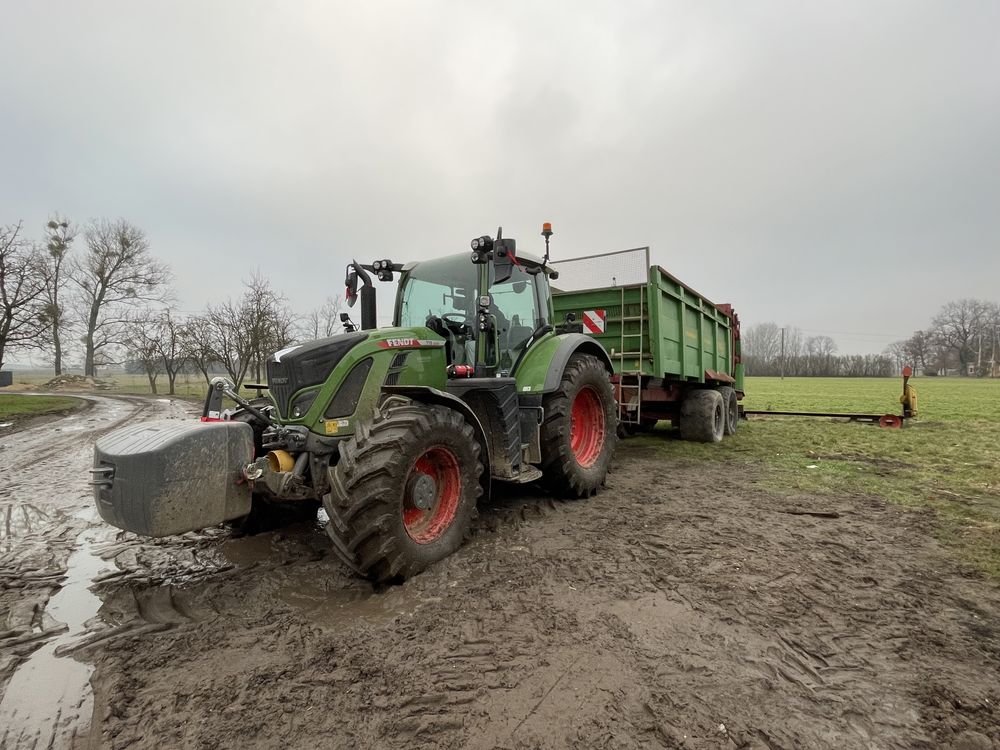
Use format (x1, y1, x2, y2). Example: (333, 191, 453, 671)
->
(92, 225, 618, 582)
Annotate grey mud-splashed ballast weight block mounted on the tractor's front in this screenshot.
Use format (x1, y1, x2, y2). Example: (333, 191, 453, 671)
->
(91, 420, 253, 536)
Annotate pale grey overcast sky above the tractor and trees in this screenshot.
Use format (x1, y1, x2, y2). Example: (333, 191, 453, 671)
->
(0, 0, 1000, 352)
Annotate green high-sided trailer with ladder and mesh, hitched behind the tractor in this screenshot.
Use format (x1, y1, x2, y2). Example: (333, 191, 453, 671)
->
(552, 248, 743, 442)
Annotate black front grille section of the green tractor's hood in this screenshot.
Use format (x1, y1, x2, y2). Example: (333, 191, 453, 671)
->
(267, 331, 370, 418)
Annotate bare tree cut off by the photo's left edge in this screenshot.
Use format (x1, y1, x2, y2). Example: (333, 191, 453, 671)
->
(0, 222, 47, 374)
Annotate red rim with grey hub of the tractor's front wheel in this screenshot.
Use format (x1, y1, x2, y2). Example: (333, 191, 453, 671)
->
(403, 446, 462, 544)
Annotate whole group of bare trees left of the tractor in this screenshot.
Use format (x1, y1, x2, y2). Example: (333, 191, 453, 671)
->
(0, 215, 340, 394)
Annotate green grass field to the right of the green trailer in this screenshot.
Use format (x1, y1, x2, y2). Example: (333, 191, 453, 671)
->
(646, 378, 1000, 578)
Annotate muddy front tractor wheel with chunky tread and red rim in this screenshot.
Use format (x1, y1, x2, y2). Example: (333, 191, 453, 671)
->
(323, 402, 483, 582)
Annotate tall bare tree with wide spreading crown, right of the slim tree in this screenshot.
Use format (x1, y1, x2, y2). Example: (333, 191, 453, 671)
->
(71, 219, 170, 375)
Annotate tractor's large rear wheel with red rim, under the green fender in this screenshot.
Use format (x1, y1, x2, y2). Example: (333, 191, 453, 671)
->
(541, 354, 618, 497)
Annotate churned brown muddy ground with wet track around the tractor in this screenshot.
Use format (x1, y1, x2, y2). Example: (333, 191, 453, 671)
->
(0, 398, 1000, 750)
